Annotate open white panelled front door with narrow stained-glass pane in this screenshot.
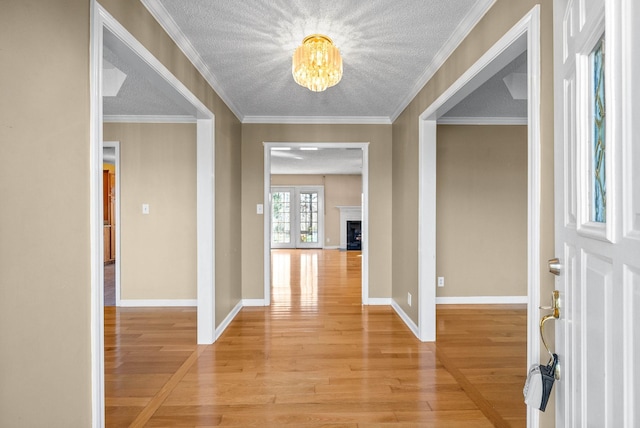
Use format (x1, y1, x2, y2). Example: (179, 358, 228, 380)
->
(553, 0, 640, 428)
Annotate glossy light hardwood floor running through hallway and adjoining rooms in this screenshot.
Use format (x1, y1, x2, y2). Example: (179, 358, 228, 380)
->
(105, 250, 526, 427)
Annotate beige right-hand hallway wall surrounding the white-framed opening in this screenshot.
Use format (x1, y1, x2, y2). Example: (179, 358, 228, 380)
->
(392, 0, 554, 427)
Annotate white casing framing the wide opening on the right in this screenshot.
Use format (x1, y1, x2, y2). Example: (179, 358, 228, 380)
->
(418, 5, 541, 427)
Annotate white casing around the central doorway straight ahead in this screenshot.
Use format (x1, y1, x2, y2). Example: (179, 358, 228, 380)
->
(263, 142, 369, 306)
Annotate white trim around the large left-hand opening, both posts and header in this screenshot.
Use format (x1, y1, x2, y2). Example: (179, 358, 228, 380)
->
(89, 4, 215, 428)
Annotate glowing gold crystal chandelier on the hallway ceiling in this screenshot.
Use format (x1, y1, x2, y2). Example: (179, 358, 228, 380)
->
(291, 34, 342, 92)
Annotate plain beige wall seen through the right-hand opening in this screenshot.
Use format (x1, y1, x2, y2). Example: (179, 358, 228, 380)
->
(436, 125, 527, 297)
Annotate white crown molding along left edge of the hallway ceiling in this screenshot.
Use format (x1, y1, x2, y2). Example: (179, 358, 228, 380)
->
(140, 0, 243, 122)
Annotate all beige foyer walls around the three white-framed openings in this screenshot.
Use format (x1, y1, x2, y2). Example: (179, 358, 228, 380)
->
(0, 0, 553, 427)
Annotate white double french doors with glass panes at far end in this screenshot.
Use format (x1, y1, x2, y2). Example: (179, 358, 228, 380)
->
(271, 186, 324, 248)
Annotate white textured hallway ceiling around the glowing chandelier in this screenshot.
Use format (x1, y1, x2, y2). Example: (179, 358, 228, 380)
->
(134, 0, 493, 123)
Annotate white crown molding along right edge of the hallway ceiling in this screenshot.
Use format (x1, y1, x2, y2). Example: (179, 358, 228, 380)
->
(388, 0, 496, 122)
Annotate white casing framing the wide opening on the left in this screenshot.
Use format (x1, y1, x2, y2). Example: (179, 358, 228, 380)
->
(90, 3, 216, 426)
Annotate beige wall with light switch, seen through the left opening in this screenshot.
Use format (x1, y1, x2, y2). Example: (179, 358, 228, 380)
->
(103, 123, 197, 300)
